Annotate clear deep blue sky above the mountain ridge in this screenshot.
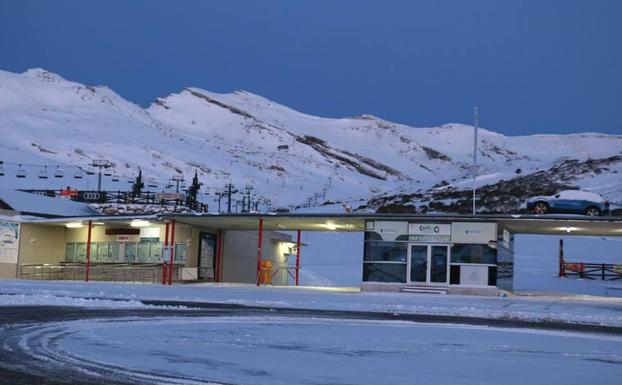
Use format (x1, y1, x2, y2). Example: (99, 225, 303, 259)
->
(0, 0, 622, 135)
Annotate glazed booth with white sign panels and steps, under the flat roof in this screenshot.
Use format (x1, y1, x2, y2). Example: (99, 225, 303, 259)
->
(362, 220, 514, 294)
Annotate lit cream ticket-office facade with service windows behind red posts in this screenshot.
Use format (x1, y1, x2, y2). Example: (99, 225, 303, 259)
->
(0, 217, 292, 285)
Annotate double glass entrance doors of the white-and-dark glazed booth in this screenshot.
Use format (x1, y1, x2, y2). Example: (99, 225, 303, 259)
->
(408, 244, 449, 285)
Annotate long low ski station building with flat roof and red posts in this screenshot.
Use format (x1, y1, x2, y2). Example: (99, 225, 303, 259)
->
(0, 213, 622, 295)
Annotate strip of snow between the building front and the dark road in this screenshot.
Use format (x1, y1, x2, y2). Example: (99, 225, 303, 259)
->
(0, 280, 622, 326)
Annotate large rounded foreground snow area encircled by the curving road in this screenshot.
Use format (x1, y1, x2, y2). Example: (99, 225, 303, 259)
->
(52, 317, 622, 385)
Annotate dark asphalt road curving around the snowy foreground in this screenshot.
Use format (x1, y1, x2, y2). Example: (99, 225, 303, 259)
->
(0, 301, 622, 385)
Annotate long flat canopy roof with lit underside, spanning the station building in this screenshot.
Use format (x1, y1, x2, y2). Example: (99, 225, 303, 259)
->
(18, 213, 622, 237)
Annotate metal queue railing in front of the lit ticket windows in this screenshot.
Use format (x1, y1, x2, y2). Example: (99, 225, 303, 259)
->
(19, 262, 183, 283)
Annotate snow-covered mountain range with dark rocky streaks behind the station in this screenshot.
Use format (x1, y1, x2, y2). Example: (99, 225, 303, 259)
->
(0, 69, 622, 210)
